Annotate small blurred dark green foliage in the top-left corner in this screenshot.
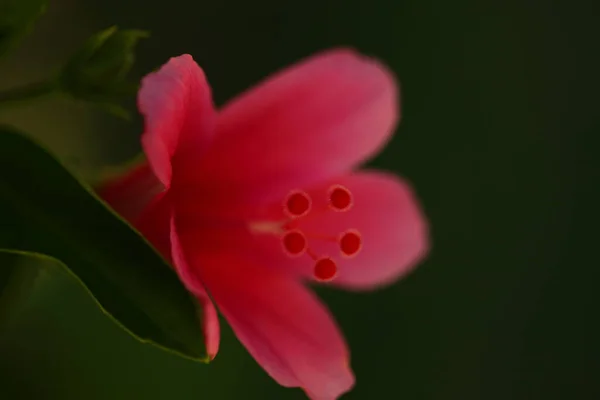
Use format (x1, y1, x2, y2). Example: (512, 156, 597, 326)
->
(0, 0, 48, 55)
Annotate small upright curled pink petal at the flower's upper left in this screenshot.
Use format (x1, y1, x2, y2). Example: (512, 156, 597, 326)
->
(138, 54, 216, 188)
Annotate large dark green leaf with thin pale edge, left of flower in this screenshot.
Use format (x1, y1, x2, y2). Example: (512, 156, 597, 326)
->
(0, 127, 207, 361)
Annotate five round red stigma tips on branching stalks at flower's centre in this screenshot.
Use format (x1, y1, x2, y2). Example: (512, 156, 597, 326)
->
(251, 185, 362, 282)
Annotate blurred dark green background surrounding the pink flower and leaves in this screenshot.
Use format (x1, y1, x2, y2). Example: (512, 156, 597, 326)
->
(0, 0, 600, 400)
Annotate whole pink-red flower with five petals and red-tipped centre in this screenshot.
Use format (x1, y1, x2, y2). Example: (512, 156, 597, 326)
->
(101, 50, 428, 399)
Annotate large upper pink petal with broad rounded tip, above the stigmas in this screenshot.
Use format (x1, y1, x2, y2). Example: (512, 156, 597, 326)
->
(182, 49, 399, 212)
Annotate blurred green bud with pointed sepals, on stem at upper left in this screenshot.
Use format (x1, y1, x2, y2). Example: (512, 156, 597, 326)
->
(59, 26, 149, 114)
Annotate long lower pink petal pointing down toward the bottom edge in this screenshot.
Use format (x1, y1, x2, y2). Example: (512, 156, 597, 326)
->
(182, 227, 354, 400)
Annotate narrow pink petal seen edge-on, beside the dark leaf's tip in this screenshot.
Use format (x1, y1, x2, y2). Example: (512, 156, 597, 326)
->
(170, 217, 220, 360)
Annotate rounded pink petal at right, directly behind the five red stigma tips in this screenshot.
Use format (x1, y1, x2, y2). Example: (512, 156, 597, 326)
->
(238, 171, 429, 290)
